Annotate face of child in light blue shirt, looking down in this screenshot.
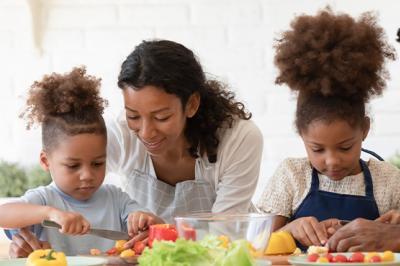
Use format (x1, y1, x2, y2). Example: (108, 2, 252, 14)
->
(40, 133, 107, 200)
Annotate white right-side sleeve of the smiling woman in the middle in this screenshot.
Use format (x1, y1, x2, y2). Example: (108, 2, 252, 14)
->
(212, 121, 263, 213)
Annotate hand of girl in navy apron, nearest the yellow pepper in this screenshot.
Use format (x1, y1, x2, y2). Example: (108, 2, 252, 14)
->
(282, 216, 328, 247)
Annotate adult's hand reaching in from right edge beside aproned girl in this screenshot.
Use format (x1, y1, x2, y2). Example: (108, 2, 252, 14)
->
(327, 218, 400, 252)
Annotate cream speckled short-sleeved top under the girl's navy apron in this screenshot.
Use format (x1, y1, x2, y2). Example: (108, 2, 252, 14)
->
(257, 158, 400, 218)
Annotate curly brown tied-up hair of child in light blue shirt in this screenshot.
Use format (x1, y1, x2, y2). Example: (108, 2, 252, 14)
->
(20, 67, 107, 151)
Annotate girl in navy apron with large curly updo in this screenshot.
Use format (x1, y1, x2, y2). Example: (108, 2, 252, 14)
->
(258, 9, 400, 249)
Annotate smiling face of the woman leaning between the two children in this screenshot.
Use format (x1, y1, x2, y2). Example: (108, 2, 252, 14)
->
(123, 86, 200, 156)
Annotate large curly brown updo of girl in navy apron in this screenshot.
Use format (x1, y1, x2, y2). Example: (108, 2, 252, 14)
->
(275, 8, 395, 132)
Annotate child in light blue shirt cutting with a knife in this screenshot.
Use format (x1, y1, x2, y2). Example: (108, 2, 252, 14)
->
(0, 68, 162, 255)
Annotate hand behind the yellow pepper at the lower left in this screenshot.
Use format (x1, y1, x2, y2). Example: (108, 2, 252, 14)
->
(8, 228, 51, 258)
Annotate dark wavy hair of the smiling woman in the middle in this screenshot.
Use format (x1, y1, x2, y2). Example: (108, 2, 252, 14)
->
(118, 40, 251, 163)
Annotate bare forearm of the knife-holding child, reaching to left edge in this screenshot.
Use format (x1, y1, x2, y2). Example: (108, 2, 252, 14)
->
(0, 202, 56, 228)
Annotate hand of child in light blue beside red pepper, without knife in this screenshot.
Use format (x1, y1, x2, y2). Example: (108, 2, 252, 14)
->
(127, 212, 164, 237)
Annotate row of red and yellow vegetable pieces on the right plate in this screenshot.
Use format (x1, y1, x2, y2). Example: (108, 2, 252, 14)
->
(307, 249, 395, 263)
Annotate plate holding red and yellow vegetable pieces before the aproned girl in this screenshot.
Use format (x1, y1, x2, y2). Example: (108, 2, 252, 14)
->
(288, 252, 400, 266)
